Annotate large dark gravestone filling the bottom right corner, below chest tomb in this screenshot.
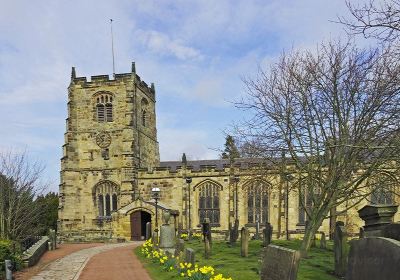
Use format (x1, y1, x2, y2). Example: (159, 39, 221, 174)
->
(346, 237, 400, 280)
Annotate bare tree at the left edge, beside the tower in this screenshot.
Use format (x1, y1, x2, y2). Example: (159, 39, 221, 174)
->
(0, 152, 45, 241)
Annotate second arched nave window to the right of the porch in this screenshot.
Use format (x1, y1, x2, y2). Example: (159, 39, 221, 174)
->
(244, 180, 269, 224)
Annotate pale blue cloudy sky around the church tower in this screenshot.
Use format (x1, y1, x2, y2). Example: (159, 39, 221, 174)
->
(0, 0, 362, 190)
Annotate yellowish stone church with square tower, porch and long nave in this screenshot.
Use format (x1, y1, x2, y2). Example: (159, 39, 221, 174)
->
(58, 63, 400, 241)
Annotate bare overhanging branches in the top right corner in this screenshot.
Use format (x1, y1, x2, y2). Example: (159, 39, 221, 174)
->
(339, 0, 400, 42)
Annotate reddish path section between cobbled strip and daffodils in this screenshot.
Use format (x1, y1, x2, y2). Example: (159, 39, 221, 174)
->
(79, 243, 151, 280)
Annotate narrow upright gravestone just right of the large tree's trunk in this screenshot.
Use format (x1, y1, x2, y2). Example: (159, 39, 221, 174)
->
(333, 221, 348, 277)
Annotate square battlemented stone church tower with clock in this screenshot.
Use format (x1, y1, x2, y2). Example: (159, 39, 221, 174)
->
(58, 63, 159, 239)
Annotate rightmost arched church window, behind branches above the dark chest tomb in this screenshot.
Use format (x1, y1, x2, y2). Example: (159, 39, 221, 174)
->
(368, 173, 396, 205)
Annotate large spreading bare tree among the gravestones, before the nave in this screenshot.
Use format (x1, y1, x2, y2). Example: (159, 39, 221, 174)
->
(237, 42, 400, 255)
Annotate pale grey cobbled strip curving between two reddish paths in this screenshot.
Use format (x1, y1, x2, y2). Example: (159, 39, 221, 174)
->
(31, 243, 145, 280)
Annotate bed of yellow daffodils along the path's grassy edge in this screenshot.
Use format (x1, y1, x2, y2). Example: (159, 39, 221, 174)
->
(140, 238, 232, 280)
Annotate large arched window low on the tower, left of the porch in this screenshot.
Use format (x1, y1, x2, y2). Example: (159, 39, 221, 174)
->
(93, 181, 118, 217)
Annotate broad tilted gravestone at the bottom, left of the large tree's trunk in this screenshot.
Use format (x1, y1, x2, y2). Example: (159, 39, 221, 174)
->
(260, 245, 300, 280)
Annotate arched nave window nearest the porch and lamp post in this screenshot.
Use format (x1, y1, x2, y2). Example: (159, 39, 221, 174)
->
(199, 182, 221, 226)
